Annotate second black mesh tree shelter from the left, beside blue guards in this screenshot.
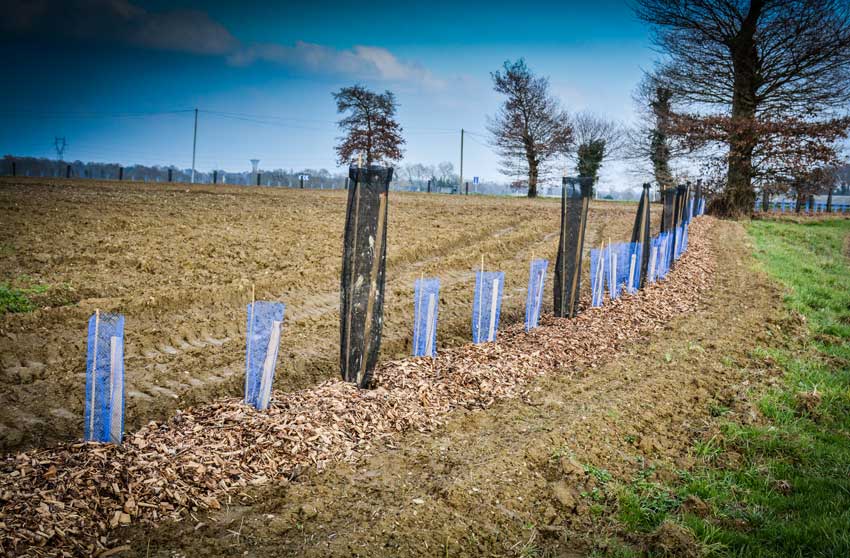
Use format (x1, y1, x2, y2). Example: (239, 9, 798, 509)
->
(554, 177, 593, 318)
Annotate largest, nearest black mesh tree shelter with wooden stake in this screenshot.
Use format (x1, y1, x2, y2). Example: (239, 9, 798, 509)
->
(339, 166, 393, 387)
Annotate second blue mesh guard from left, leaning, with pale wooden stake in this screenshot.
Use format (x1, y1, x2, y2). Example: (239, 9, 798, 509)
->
(245, 300, 285, 411)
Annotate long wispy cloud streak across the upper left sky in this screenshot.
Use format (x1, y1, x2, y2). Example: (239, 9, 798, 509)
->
(0, 0, 446, 89)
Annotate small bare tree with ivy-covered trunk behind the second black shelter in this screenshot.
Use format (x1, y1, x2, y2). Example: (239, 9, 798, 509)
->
(571, 112, 625, 190)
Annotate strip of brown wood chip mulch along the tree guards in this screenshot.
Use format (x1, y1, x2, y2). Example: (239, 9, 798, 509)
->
(0, 217, 715, 556)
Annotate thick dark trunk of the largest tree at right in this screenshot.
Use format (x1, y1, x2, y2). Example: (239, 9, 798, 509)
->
(714, 0, 764, 217)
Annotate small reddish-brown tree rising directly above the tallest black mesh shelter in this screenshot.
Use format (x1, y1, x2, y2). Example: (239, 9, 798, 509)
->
(333, 85, 405, 167)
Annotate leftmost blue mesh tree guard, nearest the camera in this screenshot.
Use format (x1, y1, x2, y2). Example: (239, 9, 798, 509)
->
(83, 312, 124, 444)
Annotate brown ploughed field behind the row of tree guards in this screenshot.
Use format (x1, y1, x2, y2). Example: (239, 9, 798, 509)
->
(0, 179, 658, 452)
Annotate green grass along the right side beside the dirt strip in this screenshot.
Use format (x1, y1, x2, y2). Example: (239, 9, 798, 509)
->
(616, 220, 850, 558)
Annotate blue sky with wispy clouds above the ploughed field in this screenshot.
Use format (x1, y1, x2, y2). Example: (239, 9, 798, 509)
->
(0, 0, 655, 189)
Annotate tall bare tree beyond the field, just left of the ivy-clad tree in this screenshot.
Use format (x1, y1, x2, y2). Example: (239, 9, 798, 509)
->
(487, 58, 572, 198)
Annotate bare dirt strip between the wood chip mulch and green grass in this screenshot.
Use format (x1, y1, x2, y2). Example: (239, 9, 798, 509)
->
(114, 223, 794, 557)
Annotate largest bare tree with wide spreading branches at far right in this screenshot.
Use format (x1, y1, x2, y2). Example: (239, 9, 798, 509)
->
(635, 0, 850, 215)
